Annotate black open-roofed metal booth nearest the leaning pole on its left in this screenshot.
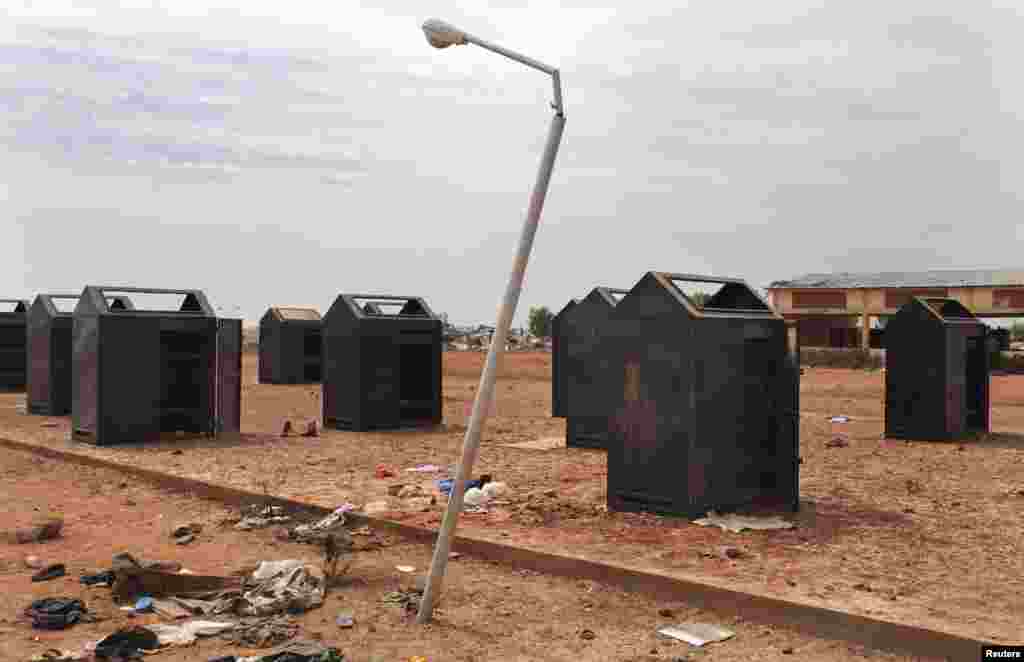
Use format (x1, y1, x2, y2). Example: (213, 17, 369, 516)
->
(324, 294, 443, 430)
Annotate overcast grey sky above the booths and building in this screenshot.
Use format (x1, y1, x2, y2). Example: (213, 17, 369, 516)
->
(0, 0, 1024, 324)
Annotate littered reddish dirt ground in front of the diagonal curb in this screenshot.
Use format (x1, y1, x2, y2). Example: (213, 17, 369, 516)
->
(0, 450, 921, 662)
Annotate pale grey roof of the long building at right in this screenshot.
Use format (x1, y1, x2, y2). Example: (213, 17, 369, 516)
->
(768, 270, 1024, 290)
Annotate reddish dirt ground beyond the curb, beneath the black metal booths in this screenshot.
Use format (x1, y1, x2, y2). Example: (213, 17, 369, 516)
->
(0, 353, 1024, 642)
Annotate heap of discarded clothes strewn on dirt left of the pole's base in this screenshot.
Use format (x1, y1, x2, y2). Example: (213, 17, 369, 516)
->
(25, 553, 344, 662)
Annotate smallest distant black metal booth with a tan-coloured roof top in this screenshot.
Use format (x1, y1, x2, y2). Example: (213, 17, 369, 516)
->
(259, 306, 323, 384)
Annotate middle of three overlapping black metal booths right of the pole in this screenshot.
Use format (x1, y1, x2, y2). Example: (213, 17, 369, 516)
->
(561, 287, 629, 450)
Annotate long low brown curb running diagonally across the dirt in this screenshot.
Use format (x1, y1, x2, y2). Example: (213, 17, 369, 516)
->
(0, 438, 991, 662)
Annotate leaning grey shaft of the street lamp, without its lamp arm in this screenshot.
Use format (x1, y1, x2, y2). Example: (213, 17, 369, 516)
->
(416, 93, 565, 624)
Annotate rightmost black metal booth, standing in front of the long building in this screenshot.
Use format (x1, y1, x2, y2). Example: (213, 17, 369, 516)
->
(886, 297, 989, 440)
